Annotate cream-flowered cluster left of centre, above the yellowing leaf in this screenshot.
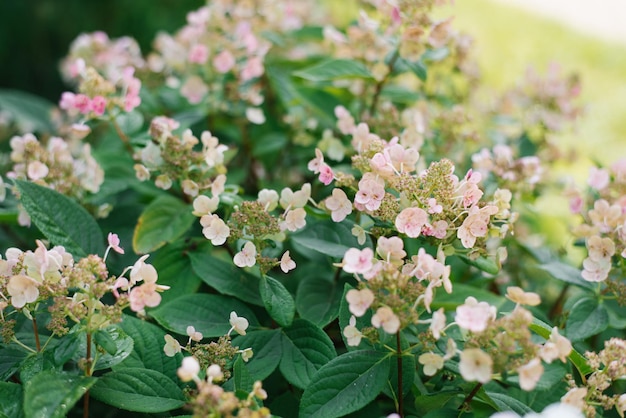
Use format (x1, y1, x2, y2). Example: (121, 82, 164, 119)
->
(134, 116, 228, 198)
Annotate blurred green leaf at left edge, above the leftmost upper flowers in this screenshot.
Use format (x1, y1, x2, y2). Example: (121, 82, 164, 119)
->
(0, 89, 54, 132)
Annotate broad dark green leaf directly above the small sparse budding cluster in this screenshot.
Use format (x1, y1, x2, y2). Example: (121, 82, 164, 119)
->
(150, 293, 258, 338)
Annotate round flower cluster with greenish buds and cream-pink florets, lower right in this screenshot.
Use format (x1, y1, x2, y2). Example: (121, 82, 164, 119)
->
(418, 287, 572, 391)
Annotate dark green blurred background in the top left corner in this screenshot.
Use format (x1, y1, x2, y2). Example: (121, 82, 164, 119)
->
(0, 0, 205, 103)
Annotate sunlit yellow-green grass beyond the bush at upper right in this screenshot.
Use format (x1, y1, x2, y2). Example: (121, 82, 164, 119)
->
(441, 0, 626, 170)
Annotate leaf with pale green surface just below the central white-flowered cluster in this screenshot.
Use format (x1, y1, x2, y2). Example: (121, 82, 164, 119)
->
(291, 221, 368, 258)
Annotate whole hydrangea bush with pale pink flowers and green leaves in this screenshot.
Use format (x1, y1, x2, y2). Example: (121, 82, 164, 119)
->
(0, 0, 626, 418)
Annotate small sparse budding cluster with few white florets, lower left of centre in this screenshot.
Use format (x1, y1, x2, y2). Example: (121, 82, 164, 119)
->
(163, 311, 254, 379)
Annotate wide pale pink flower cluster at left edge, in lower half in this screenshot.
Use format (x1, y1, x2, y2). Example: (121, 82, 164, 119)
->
(0, 234, 167, 340)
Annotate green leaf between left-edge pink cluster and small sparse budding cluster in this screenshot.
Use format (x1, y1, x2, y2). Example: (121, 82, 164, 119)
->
(113, 315, 183, 381)
